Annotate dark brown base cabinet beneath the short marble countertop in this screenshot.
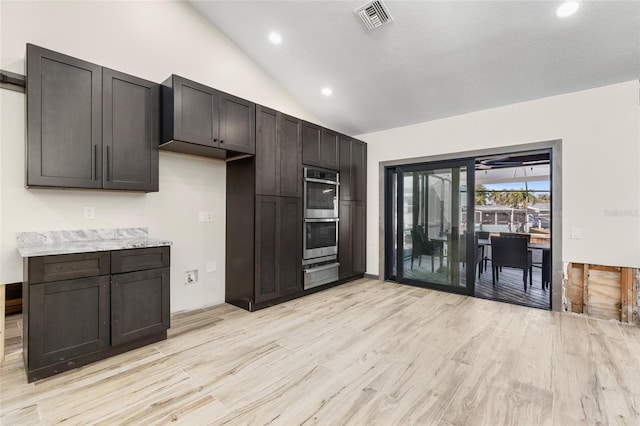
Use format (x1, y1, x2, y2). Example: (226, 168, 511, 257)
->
(23, 247, 170, 382)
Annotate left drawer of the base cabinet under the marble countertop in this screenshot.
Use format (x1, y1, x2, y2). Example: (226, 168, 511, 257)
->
(28, 251, 111, 284)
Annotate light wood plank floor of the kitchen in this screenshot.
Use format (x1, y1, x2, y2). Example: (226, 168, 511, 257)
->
(0, 279, 640, 426)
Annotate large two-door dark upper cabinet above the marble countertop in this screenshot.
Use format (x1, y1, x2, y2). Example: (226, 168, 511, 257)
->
(26, 44, 160, 192)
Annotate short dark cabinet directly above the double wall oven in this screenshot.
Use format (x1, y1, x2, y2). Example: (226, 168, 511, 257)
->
(302, 122, 340, 170)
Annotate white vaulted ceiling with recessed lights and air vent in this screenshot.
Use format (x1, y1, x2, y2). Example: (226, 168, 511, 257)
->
(189, 0, 640, 135)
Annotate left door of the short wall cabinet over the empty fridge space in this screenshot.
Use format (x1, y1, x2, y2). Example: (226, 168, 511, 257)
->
(171, 75, 220, 147)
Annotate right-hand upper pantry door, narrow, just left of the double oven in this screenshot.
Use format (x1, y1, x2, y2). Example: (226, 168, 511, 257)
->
(279, 114, 302, 197)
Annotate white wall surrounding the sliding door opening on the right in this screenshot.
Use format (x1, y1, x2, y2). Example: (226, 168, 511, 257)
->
(359, 80, 640, 275)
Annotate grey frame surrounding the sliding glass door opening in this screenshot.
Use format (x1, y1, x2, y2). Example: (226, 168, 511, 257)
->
(378, 139, 564, 312)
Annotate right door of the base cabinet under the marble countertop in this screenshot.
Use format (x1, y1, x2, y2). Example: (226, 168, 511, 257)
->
(111, 268, 170, 346)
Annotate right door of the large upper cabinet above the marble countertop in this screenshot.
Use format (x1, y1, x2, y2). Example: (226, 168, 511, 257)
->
(102, 68, 160, 192)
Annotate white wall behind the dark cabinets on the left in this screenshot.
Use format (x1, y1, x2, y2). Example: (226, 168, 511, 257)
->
(0, 1, 318, 312)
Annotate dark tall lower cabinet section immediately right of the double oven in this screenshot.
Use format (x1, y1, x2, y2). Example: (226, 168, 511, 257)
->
(338, 201, 366, 280)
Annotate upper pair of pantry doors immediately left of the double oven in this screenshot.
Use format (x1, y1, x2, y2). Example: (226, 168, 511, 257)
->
(256, 105, 302, 197)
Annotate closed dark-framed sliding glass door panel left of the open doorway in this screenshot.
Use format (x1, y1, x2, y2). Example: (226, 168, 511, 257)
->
(385, 159, 477, 294)
